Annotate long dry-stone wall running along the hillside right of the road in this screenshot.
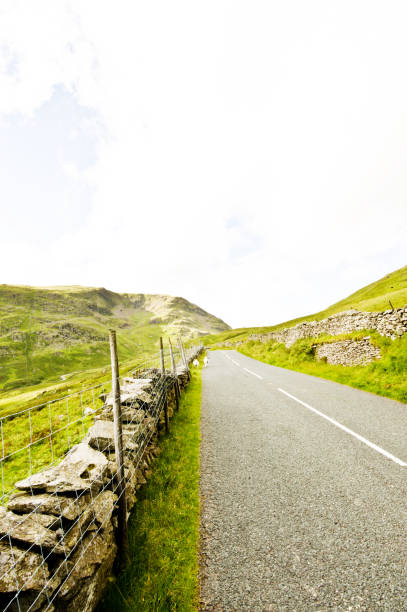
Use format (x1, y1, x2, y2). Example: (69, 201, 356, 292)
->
(249, 307, 407, 347)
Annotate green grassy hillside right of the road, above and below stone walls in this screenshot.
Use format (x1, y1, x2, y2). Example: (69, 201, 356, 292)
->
(203, 266, 407, 403)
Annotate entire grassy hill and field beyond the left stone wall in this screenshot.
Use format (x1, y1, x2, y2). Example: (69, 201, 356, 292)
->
(0, 285, 225, 482)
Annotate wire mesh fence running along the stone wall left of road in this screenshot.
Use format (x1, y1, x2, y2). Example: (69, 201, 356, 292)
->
(0, 334, 200, 612)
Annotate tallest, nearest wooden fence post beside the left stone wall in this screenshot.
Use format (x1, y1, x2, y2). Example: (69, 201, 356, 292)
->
(109, 329, 129, 564)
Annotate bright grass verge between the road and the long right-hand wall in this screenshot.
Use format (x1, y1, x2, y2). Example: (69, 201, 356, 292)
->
(238, 331, 407, 403)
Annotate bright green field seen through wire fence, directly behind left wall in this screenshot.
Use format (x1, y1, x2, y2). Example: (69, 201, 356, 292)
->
(0, 350, 169, 503)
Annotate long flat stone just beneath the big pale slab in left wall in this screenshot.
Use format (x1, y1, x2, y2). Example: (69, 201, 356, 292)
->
(7, 493, 90, 521)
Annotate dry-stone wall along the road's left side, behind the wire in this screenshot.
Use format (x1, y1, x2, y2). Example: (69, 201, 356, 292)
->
(0, 349, 201, 612)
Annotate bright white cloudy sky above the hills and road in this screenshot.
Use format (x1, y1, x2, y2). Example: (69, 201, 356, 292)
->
(0, 0, 407, 327)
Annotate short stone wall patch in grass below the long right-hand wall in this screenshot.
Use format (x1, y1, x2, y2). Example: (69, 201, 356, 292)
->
(315, 337, 381, 366)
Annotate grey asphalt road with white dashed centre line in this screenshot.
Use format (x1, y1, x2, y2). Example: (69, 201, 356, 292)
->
(201, 351, 407, 611)
